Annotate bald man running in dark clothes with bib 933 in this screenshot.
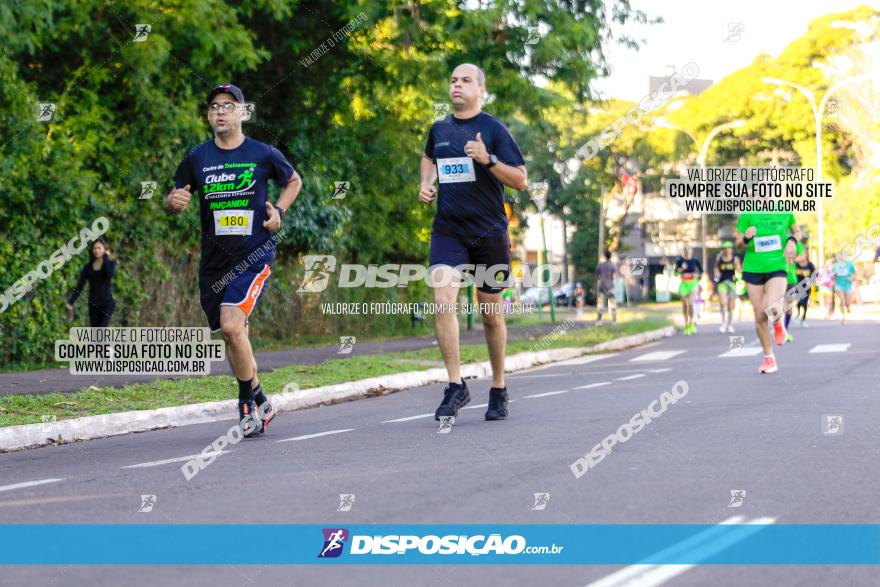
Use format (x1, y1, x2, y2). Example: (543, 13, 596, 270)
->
(419, 63, 528, 420)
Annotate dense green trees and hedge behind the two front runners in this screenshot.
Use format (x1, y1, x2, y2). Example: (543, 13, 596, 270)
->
(0, 0, 646, 364)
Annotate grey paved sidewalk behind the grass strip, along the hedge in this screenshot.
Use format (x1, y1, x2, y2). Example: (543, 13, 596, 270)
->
(0, 313, 593, 395)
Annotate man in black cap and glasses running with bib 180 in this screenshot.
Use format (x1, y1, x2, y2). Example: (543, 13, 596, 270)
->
(165, 83, 302, 438)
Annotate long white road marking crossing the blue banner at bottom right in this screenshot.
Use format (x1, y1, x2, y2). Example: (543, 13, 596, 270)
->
(587, 516, 776, 587)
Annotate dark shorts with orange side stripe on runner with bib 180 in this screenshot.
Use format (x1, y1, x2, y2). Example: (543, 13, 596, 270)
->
(199, 262, 272, 332)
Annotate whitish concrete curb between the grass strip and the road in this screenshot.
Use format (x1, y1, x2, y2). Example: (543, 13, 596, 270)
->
(0, 326, 675, 452)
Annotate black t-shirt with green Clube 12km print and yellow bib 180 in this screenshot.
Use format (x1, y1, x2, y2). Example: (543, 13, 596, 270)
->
(174, 137, 293, 274)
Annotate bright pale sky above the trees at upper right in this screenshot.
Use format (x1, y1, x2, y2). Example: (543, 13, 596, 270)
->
(593, 0, 880, 102)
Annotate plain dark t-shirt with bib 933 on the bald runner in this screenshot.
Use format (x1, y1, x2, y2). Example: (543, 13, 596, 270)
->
(425, 112, 525, 237)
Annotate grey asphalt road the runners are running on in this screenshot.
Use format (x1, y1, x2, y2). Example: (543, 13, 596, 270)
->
(0, 321, 880, 587)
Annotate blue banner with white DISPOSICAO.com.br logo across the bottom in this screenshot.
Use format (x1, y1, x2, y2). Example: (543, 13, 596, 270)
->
(0, 521, 880, 565)
